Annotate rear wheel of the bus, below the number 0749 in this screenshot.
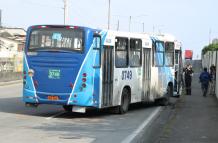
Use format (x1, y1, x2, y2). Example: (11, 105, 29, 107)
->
(118, 88, 130, 114)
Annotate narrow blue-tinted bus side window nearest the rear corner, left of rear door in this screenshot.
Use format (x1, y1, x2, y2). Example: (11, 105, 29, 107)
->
(93, 35, 101, 68)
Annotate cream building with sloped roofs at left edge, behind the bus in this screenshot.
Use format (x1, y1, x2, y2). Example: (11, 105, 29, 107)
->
(0, 27, 26, 72)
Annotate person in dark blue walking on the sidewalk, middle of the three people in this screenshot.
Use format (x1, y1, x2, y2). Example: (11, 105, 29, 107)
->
(199, 68, 211, 97)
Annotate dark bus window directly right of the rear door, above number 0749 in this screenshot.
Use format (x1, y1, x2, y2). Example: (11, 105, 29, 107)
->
(115, 37, 128, 68)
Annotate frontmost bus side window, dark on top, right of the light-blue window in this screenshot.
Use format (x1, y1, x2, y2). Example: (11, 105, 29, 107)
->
(165, 42, 174, 66)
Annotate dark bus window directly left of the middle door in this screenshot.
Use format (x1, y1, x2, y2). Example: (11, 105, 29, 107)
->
(129, 39, 142, 67)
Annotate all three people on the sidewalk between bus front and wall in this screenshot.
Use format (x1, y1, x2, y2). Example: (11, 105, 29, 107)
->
(184, 64, 216, 97)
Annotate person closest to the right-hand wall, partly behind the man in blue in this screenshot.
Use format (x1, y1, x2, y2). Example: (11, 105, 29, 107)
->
(210, 64, 216, 95)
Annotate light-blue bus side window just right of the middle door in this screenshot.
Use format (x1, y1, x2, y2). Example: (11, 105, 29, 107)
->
(153, 41, 164, 67)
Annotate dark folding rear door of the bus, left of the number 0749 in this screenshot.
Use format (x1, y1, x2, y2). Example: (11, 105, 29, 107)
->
(102, 46, 114, 107)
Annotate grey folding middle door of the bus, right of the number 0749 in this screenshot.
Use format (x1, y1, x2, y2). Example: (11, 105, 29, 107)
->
(142, 48, 151, 101)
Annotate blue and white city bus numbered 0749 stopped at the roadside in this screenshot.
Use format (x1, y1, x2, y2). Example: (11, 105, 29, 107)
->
(23, 25, 181, 114)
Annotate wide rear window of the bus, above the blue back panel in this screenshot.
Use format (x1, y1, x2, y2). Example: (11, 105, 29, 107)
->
(28, 28, 84, 51)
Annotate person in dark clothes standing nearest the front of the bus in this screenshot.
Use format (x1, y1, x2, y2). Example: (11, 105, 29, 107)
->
(185, 64, 194, 95)
